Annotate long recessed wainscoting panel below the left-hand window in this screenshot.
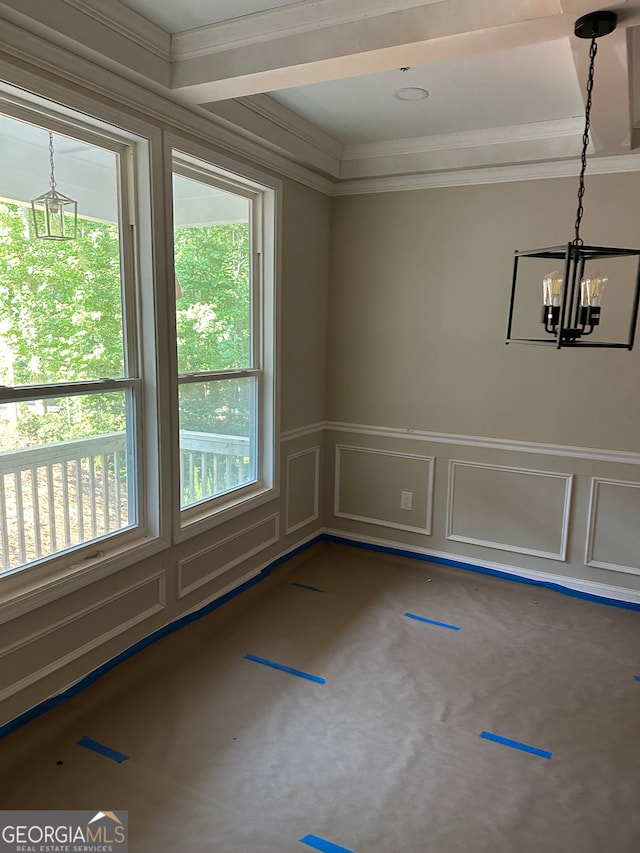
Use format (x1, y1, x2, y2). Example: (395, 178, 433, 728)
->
(0, 572, 166, 701)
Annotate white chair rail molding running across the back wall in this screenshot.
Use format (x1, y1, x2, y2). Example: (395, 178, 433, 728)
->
(327, 421, 640, 465)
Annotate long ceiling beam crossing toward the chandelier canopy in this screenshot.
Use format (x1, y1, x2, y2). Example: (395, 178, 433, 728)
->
(171, 0, 564, 104)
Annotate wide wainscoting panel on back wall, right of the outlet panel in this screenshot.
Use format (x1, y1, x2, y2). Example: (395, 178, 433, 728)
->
(447, 460, 573, 560)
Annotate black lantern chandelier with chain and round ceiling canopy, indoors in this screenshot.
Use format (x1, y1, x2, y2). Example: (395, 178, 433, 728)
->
(506, 12, 640, 350)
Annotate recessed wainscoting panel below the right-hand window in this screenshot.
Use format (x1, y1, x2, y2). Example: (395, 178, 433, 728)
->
(178, 513, 280, 598)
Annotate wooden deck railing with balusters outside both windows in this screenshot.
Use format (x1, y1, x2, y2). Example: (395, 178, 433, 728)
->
(0, 431, 251, 572)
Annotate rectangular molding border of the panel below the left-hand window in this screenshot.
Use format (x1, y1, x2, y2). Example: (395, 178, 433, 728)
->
(0, 570, 166, 702)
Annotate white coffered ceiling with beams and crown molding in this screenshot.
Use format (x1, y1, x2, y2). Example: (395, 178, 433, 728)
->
(0, 0, 640, 188)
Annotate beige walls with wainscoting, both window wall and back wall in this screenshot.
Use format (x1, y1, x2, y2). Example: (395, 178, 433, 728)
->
(0, 13, 640, 725)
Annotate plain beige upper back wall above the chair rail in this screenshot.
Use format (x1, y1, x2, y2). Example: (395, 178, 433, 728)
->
(329, 173, 640, 451)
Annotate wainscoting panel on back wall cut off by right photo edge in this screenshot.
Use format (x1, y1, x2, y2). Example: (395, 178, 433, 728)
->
(585, 477, 640, 575)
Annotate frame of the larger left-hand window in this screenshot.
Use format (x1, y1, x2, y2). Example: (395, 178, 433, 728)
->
(0, 90, 168, 588)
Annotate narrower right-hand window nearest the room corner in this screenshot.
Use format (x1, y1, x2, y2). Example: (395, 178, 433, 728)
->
(173, 152, 275, 520)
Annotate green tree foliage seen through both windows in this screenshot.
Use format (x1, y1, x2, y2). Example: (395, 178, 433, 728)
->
(0, 203, 251, 443)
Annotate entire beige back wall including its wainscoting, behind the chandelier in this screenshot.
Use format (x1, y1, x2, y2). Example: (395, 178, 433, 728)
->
(326, 174, 640, 601)
